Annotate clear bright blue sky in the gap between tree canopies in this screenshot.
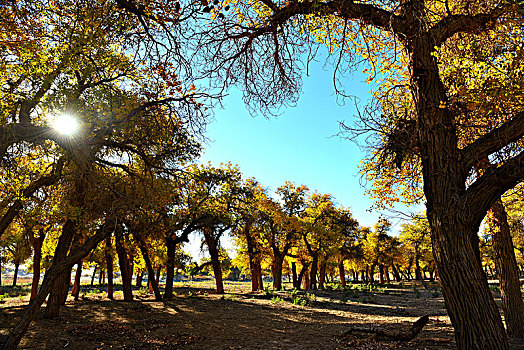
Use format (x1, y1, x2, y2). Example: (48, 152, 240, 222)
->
(186, 56, 414, 257)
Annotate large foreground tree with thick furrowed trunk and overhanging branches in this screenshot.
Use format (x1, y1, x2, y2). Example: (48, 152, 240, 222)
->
(199, 0, 524, 349)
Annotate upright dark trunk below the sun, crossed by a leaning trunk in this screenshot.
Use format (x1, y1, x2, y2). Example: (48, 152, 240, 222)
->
(45, 219, 76, 318)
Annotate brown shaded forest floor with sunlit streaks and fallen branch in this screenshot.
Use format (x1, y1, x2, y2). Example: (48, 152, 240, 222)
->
(0, 281, 524, 349)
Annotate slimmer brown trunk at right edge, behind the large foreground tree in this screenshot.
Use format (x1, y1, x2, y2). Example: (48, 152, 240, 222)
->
(490, 199, 524, 338)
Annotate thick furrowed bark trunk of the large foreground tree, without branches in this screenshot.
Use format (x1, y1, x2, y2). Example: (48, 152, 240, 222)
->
(412, 30, 508, 350)
